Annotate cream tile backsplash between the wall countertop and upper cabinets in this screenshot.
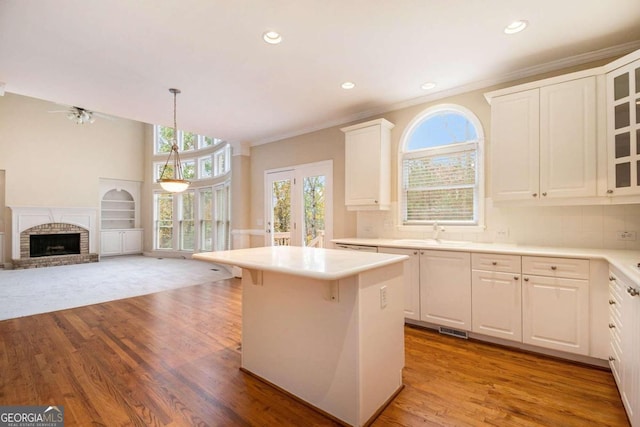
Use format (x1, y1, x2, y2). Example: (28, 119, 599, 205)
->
(357, 200, 640, 250)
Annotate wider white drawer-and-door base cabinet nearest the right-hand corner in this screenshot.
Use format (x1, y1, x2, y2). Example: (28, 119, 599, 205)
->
(522, 256, 590, 355)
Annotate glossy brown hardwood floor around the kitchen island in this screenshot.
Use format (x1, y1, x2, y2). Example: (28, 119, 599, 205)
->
(0, 279, 629, 427)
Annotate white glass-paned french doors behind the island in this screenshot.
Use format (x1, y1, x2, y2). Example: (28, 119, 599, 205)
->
(265, 160, 333, 248)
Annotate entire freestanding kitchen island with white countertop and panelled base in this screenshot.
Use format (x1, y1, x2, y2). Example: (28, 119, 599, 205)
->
(193, 246, 408, 426)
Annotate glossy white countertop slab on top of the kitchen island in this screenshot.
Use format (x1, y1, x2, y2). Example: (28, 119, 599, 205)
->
(193, 246, 409, 280)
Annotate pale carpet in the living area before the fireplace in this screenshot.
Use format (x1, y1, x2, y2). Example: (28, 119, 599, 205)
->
(0, 255, 232, 320)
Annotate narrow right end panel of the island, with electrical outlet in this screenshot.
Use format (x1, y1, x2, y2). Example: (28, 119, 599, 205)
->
(358, 262, 405, 425)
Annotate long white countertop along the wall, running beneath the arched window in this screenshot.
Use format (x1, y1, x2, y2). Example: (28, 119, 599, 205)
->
(332, 238, 640, 284)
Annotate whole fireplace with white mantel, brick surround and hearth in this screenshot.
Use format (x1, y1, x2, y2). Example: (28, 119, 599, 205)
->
(11, 207, 98, 269)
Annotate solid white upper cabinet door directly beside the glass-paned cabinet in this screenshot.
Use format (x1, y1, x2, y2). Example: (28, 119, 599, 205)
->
(540, 76, 597, 199)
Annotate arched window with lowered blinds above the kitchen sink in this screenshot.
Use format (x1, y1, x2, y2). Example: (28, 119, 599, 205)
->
(398, 104, 484, 226)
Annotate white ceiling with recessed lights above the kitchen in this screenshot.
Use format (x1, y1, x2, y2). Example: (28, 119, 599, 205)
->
(0, 0, 640, 144)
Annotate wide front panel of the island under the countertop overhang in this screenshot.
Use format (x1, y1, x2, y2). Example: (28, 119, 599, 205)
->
(241, 271, 360, 425)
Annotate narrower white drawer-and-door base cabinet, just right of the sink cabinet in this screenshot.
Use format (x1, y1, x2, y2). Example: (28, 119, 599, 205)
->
(471, 253, 522, 341)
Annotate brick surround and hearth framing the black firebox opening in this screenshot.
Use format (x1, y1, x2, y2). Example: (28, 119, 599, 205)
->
(13, 222, 98, 269)
